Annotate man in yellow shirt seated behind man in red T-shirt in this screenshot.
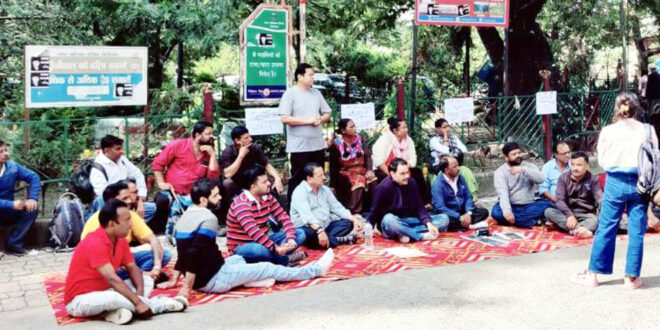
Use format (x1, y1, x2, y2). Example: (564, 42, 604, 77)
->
(80, 181, 171, 282)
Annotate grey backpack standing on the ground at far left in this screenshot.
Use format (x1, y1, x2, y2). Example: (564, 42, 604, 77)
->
(48, 192, 85, 251)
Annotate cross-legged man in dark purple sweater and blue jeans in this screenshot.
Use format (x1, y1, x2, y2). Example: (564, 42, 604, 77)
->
(369, 158, 449, 243)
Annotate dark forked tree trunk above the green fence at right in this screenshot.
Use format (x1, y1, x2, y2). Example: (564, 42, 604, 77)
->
(479, 0, 561, 95)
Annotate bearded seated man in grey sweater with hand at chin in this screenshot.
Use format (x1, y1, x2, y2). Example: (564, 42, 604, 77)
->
(492, 142, 552, 228)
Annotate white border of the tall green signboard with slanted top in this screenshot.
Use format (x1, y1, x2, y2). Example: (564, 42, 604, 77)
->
(238, 3, 294, 106)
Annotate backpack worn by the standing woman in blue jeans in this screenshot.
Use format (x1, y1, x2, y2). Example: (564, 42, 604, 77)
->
(637, 124, 660, 201)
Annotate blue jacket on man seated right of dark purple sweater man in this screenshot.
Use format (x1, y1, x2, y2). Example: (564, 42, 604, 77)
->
(431, 173, 474, 219)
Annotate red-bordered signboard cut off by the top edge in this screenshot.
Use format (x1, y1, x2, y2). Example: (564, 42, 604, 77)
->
(415, 0, 511, 28)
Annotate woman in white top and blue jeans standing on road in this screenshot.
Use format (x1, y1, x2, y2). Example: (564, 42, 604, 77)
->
(571, 92, 658, 289)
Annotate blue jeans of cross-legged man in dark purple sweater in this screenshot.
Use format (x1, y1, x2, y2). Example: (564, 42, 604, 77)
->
(380, 213, 449, 241)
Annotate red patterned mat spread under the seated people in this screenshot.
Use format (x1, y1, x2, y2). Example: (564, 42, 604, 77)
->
(44, 227, 604, 325)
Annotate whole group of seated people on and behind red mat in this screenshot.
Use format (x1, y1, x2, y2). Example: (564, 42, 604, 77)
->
(0, 119, 648, 323)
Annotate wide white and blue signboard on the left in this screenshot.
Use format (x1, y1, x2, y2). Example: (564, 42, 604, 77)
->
(24, 46, 149, 108)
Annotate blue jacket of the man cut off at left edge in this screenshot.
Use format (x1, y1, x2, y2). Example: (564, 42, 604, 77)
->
(0, 160, 41, 211)
